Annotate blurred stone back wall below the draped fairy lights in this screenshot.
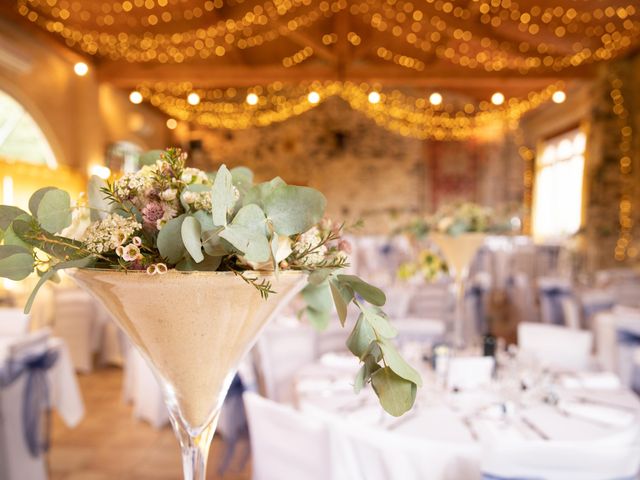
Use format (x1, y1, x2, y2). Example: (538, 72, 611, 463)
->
(191, 98, 522, 233)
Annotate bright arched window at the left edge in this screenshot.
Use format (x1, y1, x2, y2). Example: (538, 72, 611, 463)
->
(0, 90, 58, 168)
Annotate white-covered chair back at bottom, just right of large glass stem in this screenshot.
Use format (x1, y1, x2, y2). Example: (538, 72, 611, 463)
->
(243, 392, 333, 480)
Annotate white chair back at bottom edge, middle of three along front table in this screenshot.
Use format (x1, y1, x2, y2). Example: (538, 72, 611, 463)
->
(332, 421, 480, 480)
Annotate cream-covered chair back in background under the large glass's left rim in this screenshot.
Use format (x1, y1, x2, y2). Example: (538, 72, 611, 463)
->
(53, 288, 96, 373)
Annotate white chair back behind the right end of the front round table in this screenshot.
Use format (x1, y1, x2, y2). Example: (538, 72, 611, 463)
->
(518, 323, 593, 370)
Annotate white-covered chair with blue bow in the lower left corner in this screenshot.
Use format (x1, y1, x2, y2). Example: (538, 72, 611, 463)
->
(0, 331, 56, 480)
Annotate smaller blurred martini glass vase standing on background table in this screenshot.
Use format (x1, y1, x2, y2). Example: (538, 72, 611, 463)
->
(429, 232, 486, 347)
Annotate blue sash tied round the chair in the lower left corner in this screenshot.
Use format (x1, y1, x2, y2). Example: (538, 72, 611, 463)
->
(0, 349, 58, 458)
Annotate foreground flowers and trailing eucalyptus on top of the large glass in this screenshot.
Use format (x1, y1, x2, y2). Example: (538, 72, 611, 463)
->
(0, 149, 422, 415)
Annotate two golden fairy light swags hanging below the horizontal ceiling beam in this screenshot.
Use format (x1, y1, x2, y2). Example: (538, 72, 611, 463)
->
(139, 81, 562, 140)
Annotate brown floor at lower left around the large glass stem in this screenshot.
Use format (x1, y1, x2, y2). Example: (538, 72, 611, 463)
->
(49, 368, 251, 480)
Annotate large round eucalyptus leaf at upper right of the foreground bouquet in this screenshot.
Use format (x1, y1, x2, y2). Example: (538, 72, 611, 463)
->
(264, 185, 327, 235)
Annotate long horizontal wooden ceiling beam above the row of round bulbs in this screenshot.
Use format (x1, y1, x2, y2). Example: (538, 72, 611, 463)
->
(98, 62, 594, 89)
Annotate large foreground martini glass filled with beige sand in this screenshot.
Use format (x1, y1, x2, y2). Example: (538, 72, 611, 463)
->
(71, 269, 305, 480)
